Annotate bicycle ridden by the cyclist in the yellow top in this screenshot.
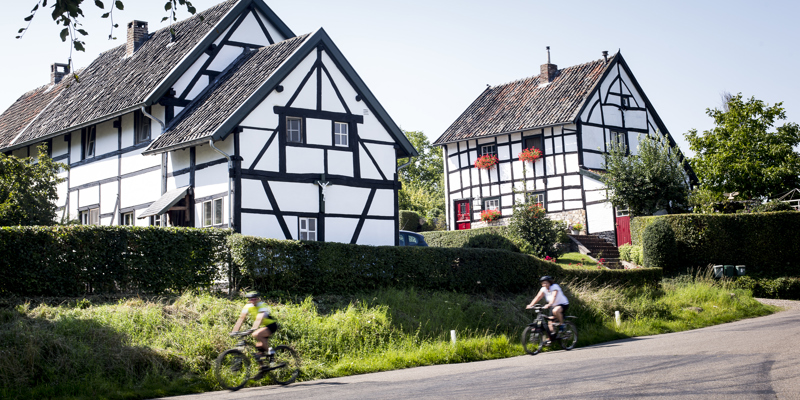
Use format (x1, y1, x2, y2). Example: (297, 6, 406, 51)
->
(214, 329, 300, 391)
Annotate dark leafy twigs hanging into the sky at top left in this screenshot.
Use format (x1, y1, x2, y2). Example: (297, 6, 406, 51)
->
(17, 0, 197, 54)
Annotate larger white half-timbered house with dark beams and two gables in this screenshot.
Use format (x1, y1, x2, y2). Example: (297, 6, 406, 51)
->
(0, 0, 417, 245)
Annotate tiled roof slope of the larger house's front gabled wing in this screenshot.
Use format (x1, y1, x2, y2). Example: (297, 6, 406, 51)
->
(146, 34, 309, 153)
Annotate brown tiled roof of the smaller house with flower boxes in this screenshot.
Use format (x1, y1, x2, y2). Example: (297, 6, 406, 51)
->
(434, 56, 611, 144)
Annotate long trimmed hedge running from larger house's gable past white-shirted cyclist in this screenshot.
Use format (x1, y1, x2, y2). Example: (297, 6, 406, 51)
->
(228, 235, 661, 294)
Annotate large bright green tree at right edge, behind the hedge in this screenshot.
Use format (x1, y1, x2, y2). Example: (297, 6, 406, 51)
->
(686, 93, 800, 199)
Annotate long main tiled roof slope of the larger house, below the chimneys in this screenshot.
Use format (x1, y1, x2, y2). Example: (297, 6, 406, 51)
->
(6, 0, 239, 148)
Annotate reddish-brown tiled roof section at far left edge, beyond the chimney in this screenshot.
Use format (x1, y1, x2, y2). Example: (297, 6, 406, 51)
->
(0, 79, 68, 148)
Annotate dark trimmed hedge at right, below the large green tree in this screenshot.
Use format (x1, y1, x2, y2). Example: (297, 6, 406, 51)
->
(631, 211, 800, 277)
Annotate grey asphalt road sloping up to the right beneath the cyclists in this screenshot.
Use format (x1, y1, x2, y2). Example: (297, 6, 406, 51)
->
(162, 308, 800, 400)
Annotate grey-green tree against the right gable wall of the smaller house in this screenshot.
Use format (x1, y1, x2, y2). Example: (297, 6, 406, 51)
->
(602, 133, 689, 216)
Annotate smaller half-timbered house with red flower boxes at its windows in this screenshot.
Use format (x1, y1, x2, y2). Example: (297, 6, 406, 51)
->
(434, 48, 692, 244)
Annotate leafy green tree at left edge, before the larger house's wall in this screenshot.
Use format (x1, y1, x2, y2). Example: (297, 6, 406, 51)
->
(0, 144, 69, 226)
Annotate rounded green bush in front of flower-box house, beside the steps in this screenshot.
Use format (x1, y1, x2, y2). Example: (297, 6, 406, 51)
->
(508, 199, 566, 258)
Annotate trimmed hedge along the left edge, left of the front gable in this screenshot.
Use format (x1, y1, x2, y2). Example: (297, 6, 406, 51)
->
(0, 226, 229, 296)
